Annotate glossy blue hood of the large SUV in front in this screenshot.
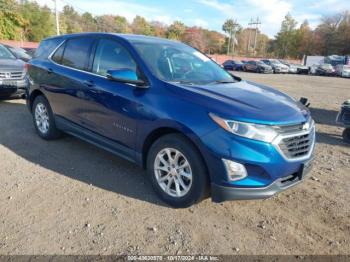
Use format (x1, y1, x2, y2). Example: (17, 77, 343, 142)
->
(172, 81, 310, 125)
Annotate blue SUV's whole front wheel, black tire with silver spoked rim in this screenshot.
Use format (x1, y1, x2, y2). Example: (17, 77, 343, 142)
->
(147, 134, 209, 208)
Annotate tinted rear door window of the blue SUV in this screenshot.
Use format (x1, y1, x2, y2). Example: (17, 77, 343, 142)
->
(62, 37, 94, 70)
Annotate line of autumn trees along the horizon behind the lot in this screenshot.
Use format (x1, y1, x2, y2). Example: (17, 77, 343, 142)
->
(0, 0, 350, 58)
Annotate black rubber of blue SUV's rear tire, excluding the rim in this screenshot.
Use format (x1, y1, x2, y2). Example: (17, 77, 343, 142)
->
(32, 96, 62, 140)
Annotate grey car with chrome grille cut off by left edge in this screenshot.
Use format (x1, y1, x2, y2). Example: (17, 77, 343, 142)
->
(0, 44, 27, 98)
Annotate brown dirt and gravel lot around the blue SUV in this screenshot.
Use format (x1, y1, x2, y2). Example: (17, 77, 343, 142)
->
(0, 73, 350, 254)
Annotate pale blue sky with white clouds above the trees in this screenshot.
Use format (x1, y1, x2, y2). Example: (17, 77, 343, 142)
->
(35, 0, 350, 38)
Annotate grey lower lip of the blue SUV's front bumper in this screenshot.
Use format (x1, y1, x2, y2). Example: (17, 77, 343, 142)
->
(211, 160, 312, 203)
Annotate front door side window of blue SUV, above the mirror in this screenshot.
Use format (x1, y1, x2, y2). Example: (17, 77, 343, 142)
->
(92, 39, 136, 76)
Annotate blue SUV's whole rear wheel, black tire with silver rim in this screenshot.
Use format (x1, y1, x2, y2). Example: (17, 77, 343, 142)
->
(32, 96, 62, 140)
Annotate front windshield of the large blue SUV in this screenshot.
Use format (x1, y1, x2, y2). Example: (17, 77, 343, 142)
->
(133, 41, 234, 84)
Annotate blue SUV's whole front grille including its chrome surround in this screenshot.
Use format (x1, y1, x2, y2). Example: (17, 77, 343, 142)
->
(273, 122, 316, 161)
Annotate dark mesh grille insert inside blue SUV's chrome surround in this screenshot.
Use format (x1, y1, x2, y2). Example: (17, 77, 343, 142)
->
(278, 128, 315, 159)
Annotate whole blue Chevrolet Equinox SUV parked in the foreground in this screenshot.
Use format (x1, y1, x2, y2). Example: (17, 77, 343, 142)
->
(27, 33, 315, 207)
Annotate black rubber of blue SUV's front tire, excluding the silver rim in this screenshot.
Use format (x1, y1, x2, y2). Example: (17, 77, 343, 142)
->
(147, 134, 209, 208)
